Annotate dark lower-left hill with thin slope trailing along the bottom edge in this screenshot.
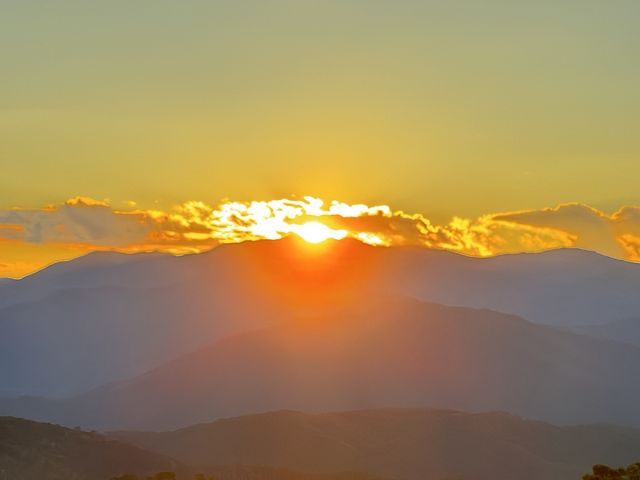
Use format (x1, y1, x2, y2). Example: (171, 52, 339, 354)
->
(0, 417, 384, 480)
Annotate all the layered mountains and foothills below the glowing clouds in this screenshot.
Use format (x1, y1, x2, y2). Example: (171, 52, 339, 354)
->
(0, 239, 640, 480)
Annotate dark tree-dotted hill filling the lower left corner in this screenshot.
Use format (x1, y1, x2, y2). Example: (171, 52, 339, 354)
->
(0, 417, 192, 480)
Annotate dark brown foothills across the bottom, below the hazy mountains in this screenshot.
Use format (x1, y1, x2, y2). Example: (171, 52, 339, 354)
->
(5, 408, 640, 480)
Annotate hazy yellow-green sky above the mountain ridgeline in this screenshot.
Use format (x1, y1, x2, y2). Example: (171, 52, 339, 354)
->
(0, 0, 640, 277)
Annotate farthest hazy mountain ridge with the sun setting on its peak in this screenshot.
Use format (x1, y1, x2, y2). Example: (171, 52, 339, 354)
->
(0, 238, 640, 397)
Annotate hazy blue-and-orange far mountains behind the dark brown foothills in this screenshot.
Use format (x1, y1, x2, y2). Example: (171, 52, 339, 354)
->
(0, 239, 640, 429)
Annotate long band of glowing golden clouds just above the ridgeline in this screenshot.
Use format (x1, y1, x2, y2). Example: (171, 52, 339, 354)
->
(0, 197, 640, 278)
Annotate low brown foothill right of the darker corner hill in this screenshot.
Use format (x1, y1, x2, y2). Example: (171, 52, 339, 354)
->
(110, 409, 640, 480)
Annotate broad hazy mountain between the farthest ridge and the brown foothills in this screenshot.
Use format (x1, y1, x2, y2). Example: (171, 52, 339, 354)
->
(7, 299, 640, 430)
